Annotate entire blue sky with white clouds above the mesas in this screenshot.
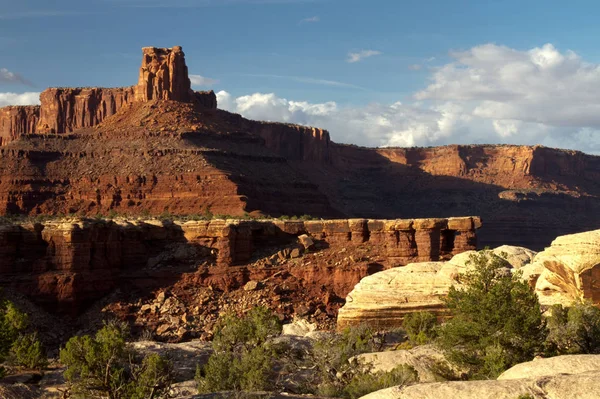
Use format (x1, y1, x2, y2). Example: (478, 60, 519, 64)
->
(0, 0, 600, 152)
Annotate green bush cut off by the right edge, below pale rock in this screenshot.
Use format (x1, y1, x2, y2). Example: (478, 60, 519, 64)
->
(546, 302, 600, 355)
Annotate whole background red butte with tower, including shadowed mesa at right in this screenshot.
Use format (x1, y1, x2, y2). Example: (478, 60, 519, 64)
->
(0, 47, 600, 250)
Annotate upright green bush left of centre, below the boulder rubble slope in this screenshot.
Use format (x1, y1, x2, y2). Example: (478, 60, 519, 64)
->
(196, 307, 281, 393)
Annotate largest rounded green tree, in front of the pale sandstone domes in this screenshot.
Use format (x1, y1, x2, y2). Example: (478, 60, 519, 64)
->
(438, 250, 548, 379)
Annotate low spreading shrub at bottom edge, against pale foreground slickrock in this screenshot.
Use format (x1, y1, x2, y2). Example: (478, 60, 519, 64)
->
(343, 364, 418, 399)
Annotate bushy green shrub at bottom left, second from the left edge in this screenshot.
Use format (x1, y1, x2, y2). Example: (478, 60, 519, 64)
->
(60, 323, 172, 399)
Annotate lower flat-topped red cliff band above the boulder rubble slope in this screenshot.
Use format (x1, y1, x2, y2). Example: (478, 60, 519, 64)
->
(0, 217, 481, 314)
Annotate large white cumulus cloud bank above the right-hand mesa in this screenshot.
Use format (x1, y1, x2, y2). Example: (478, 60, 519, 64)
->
(218, 44, 600, 153)
